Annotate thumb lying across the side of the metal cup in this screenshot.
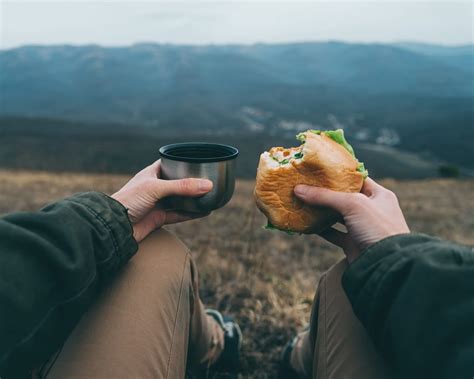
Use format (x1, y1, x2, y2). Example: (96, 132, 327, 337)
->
(152, 178, 212, 200)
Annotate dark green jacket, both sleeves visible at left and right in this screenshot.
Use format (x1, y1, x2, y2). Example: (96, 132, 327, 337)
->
(0, 193, 474, 379)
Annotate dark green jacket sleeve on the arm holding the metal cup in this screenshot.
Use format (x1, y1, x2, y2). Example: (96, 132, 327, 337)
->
(0, 192, 137, 379)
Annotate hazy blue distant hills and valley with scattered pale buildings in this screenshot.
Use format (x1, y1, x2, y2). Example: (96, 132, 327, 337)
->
(0, 42, 474, 172)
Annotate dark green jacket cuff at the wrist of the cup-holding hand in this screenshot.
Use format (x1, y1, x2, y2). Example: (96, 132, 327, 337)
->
(69, 192, 138, 267)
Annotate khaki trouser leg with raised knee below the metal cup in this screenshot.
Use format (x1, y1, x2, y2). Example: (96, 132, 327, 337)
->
(45, 229, 218, 379)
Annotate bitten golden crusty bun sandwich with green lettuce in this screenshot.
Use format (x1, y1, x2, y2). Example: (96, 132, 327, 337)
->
(254, 129, 367, 233)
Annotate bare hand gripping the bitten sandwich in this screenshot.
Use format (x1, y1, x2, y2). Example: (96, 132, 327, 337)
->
(294, 178, 410, 263)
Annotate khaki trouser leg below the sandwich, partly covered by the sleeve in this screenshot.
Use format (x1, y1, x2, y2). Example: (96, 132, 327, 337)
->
(292, 259, 391, 379)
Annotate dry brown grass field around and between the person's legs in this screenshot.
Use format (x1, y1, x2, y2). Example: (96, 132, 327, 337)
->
(0, 171, 474, 378)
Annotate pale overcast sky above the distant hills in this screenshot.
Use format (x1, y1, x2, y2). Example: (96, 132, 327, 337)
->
(0, 0, 474, 48)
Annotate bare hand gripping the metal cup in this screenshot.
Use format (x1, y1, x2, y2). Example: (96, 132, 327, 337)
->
(112, 160, 212, 242)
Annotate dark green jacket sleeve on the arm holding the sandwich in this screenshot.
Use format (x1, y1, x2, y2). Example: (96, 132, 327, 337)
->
(342, 234, 474, 379)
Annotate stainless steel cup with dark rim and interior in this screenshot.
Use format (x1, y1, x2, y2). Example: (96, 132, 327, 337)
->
(159, 142, 239, 212)
